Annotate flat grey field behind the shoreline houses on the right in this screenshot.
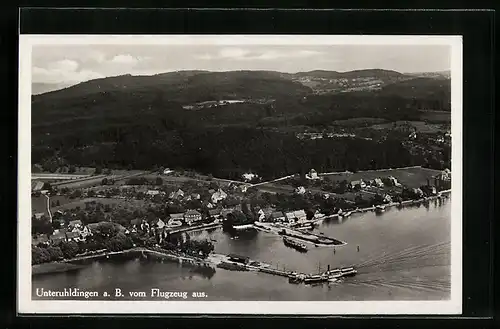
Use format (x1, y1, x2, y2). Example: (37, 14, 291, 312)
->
(323, 167, 440, 188)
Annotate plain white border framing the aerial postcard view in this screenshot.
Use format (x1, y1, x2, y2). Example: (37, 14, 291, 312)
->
(17, 35, 462, 315)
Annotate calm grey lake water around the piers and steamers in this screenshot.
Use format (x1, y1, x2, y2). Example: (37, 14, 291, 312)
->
(32, 199, 452, 301)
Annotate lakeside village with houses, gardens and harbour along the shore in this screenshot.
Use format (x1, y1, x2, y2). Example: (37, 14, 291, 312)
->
(32, 167, 451, 263)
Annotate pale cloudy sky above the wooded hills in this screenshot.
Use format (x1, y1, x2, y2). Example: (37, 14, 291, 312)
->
(32, 44, 451, 84)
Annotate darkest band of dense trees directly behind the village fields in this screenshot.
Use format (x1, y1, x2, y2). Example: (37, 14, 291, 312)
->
(33, 127, 423, 179)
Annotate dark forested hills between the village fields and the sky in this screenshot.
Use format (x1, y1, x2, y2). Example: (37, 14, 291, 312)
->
(32, 71, 450, 178)
